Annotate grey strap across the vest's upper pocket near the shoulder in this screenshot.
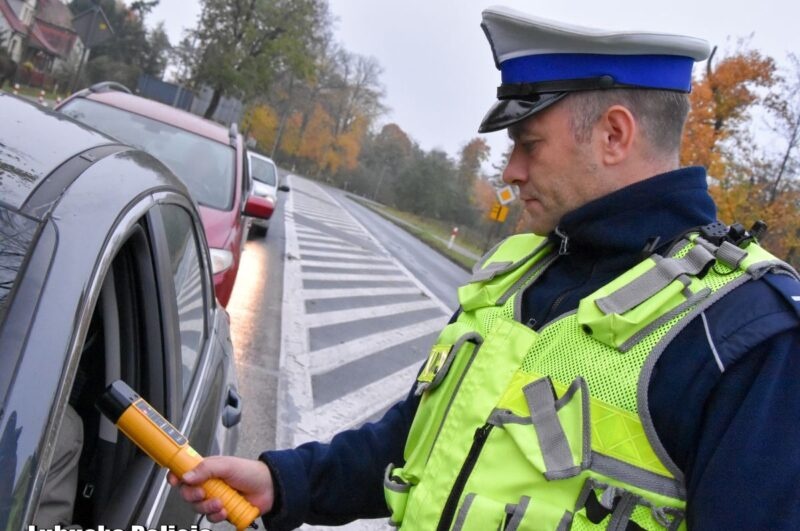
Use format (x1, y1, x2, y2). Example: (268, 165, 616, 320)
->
(595, 245, 714, 315)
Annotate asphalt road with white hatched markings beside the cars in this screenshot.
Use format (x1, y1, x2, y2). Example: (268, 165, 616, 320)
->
(222, 176, 469, 530)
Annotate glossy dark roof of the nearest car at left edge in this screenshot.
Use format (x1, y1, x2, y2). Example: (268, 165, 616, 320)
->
(0, 91, 118, 209)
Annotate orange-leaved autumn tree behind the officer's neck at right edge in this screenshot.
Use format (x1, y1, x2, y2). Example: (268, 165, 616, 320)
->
(681, 46, 800, 268)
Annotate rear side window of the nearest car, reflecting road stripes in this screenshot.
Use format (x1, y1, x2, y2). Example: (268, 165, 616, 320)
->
(161, 204, 206, 399)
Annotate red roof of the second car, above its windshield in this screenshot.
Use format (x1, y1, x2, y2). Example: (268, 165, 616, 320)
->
(80, 91, 230, 144)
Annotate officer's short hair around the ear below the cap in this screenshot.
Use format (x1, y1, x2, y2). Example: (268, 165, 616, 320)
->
(564, 89, 690, 154)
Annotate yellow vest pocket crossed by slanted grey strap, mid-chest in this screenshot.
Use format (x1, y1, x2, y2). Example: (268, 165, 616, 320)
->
(500, 373, 592, 480)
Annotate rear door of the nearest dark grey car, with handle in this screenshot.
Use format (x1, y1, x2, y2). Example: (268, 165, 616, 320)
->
(148, 196, 242, 523)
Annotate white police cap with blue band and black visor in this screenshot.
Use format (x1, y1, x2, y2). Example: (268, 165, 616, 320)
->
(478, 7, 711, 133)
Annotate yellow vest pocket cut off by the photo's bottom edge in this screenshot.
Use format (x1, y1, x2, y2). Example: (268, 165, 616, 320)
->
(452, 493, 572, 531)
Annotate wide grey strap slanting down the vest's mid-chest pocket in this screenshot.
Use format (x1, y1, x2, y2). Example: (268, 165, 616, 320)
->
(522, 378, 580, 479)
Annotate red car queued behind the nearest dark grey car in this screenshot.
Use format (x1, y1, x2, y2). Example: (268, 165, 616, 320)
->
(58, 83, 275, 306)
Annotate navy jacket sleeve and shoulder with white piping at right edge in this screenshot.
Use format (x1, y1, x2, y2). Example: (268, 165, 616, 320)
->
(649, 282, 800, 530)
